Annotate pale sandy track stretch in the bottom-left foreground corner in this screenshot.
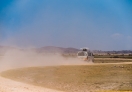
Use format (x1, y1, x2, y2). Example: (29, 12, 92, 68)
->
(0, 77, 62, 92)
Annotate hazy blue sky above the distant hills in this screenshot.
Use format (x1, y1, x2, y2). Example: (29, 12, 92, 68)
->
(0, 0, 132, 50)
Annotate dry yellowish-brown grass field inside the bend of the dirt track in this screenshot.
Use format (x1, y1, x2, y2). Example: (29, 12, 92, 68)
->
(1, 64, 132, 92)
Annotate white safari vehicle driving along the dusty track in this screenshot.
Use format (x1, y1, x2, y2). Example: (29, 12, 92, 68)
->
(77, 48, 94, 62)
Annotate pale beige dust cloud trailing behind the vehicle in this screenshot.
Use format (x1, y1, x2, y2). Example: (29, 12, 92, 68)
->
(0, 49, 86, 71)
